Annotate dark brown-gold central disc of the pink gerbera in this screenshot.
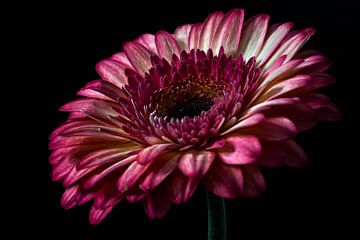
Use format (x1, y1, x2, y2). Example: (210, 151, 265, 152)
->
(154, 78, 222, 120)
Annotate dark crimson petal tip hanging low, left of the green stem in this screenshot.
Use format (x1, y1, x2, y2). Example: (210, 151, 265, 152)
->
(144, 188, 172, 219)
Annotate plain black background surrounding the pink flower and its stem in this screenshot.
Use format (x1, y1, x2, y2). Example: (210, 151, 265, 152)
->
(17, 0, 359, 240)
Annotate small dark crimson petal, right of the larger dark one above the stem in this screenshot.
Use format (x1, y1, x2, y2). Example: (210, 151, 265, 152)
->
(241, 166, 265, 197)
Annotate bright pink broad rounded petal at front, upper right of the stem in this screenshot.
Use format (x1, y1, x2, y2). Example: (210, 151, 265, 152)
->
(217, 135, 261, 164)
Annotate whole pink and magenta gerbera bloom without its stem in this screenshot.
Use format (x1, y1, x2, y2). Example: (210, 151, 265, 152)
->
(49, 9, 340, 224)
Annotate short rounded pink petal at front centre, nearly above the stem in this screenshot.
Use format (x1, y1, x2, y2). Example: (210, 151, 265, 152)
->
(178, 151, 215, 178)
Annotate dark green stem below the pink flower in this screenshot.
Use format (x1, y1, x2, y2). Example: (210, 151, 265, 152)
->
(206, 192, 226, 240)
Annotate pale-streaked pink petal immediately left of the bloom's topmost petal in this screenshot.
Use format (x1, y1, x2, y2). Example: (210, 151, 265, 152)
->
(199, 12, 224, 52)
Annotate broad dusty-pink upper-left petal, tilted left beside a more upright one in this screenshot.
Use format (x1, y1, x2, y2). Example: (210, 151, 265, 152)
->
(123, 42, 153, 76)
